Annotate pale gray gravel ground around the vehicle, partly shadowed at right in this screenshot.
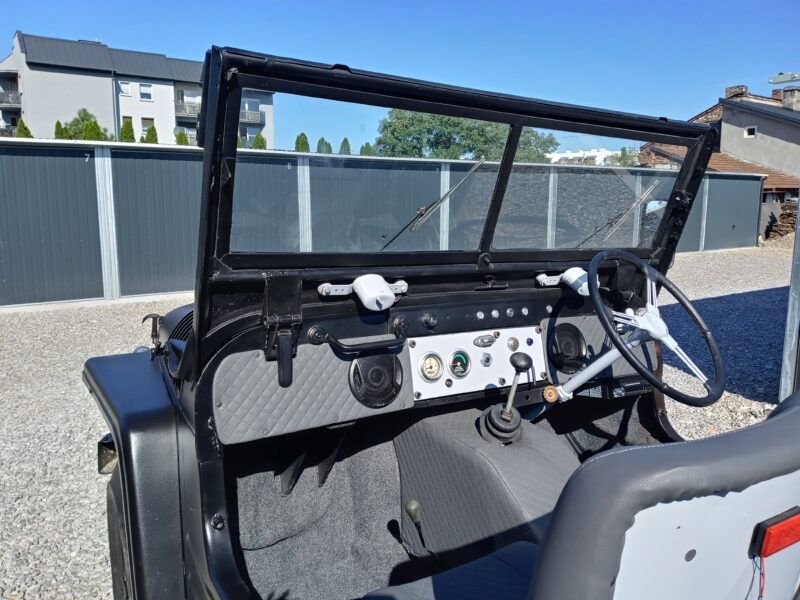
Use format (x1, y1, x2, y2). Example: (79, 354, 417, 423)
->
(0, 240, 791, 599)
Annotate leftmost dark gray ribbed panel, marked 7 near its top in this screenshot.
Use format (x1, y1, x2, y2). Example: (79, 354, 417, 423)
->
(0, 145, 103, 304)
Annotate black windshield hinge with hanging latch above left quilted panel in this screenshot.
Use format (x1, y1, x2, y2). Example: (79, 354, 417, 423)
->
(262, 271, 303, 387)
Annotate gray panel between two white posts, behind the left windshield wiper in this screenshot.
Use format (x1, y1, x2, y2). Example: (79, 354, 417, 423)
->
(309, 157, 441, 252)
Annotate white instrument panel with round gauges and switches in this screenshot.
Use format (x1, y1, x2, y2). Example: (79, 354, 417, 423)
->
(408, 325, 547, 400)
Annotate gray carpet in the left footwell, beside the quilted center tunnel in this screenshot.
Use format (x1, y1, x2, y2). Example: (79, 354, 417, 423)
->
(237, 428, 408, 600)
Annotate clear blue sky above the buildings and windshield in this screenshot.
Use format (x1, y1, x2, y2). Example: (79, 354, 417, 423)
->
(0, 0, 800, 149)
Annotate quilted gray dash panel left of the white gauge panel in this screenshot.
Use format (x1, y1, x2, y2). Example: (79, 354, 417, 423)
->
(212, 336, 414, 444)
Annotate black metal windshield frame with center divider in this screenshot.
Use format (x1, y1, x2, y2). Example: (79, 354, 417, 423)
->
(196, 47, 718, 346)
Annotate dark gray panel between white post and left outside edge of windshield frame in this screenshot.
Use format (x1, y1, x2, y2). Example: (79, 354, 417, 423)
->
(111, 150, 203, 295)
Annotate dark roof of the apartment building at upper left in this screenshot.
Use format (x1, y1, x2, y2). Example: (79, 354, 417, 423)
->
(17, 31, 203, 83)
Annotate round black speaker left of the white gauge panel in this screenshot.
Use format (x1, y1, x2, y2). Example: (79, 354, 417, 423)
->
(349, 354, 403, 408)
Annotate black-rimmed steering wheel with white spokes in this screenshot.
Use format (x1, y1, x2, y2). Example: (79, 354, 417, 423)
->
(587, 248, 725, 407)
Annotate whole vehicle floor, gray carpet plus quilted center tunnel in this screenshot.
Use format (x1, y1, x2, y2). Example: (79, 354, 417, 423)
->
(229, 400, 656, 600)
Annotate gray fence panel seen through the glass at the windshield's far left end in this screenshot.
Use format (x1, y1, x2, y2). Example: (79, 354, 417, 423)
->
(231, 155, 300, 252)
